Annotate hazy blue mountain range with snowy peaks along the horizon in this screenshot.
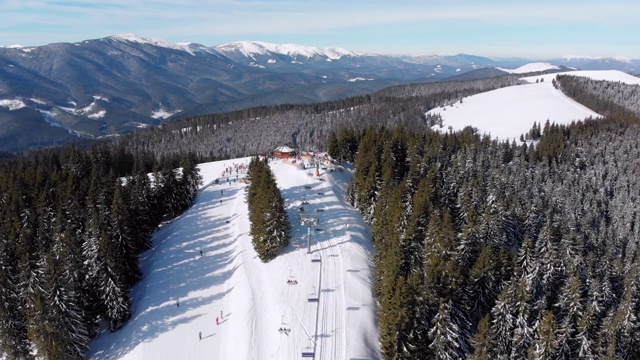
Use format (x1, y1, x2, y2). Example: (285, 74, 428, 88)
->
(0, 34, 640, 151)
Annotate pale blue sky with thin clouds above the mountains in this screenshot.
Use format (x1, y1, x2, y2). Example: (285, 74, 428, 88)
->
(0, 0, 640, 59)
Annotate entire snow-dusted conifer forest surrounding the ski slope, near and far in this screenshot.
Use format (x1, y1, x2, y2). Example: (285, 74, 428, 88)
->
(0, 71, 640, 360)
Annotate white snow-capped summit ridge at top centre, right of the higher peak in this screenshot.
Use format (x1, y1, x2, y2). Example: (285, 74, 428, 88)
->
(215, 41, 361, 60)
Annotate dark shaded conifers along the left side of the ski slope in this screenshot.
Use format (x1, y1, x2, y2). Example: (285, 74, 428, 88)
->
(0, 145, 201, 360)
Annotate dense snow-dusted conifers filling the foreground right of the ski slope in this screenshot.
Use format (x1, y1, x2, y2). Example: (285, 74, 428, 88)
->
(348, 112, 640, 359)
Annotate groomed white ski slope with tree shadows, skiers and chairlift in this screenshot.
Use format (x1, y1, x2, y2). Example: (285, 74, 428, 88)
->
(87, 158, 380, 360)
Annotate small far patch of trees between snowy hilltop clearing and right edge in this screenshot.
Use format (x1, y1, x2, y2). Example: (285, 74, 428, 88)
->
(553, 75, 640, 116)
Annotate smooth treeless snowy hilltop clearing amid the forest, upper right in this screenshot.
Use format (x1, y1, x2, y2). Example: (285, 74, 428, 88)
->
(427, 70, 640, 141)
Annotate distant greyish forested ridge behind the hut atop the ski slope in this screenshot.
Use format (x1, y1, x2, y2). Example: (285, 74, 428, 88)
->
(119, 75, 520, 161)
